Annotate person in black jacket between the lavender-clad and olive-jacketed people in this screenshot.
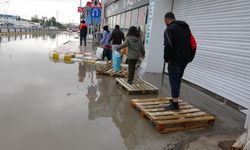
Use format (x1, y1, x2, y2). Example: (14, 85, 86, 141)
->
(109, 25, 125, 53)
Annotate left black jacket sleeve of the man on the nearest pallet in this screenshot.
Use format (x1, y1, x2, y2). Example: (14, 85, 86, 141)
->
(164, 28, 173, 62)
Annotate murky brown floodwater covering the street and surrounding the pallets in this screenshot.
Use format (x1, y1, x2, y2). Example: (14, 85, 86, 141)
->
(0, 34, 245, 150)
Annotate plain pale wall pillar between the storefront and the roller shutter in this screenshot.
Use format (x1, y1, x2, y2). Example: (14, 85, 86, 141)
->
(146, 0, 172, 73)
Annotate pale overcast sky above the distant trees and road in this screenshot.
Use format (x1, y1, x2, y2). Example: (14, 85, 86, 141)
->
(0, 0, 90, 23)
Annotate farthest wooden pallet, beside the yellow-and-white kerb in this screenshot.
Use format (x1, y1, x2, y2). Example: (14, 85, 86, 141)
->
(96, 66, 128, 78)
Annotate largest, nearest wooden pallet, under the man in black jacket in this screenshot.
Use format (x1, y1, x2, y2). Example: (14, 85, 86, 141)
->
(131, 98, 215, 133)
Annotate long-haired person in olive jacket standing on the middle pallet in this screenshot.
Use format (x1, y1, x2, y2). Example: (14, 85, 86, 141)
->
(117, 26, 145, 84)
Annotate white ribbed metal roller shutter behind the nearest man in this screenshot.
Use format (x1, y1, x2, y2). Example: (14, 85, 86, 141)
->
(173, 0, 250, 108)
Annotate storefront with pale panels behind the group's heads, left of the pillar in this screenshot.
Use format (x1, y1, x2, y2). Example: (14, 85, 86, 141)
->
(104, 0, 149, 31)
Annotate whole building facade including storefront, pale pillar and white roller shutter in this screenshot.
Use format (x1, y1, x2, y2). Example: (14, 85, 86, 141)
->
(103, 0, 250, 112)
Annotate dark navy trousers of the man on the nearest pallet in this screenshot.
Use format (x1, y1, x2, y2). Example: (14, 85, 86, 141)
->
(168, 62, 187, 98)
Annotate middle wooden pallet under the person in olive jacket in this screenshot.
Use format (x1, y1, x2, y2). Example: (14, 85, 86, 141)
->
(116, 78, 159, 94)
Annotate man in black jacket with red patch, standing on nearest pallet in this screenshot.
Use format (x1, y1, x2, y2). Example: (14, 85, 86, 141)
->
(164, 12, 197, 110)
